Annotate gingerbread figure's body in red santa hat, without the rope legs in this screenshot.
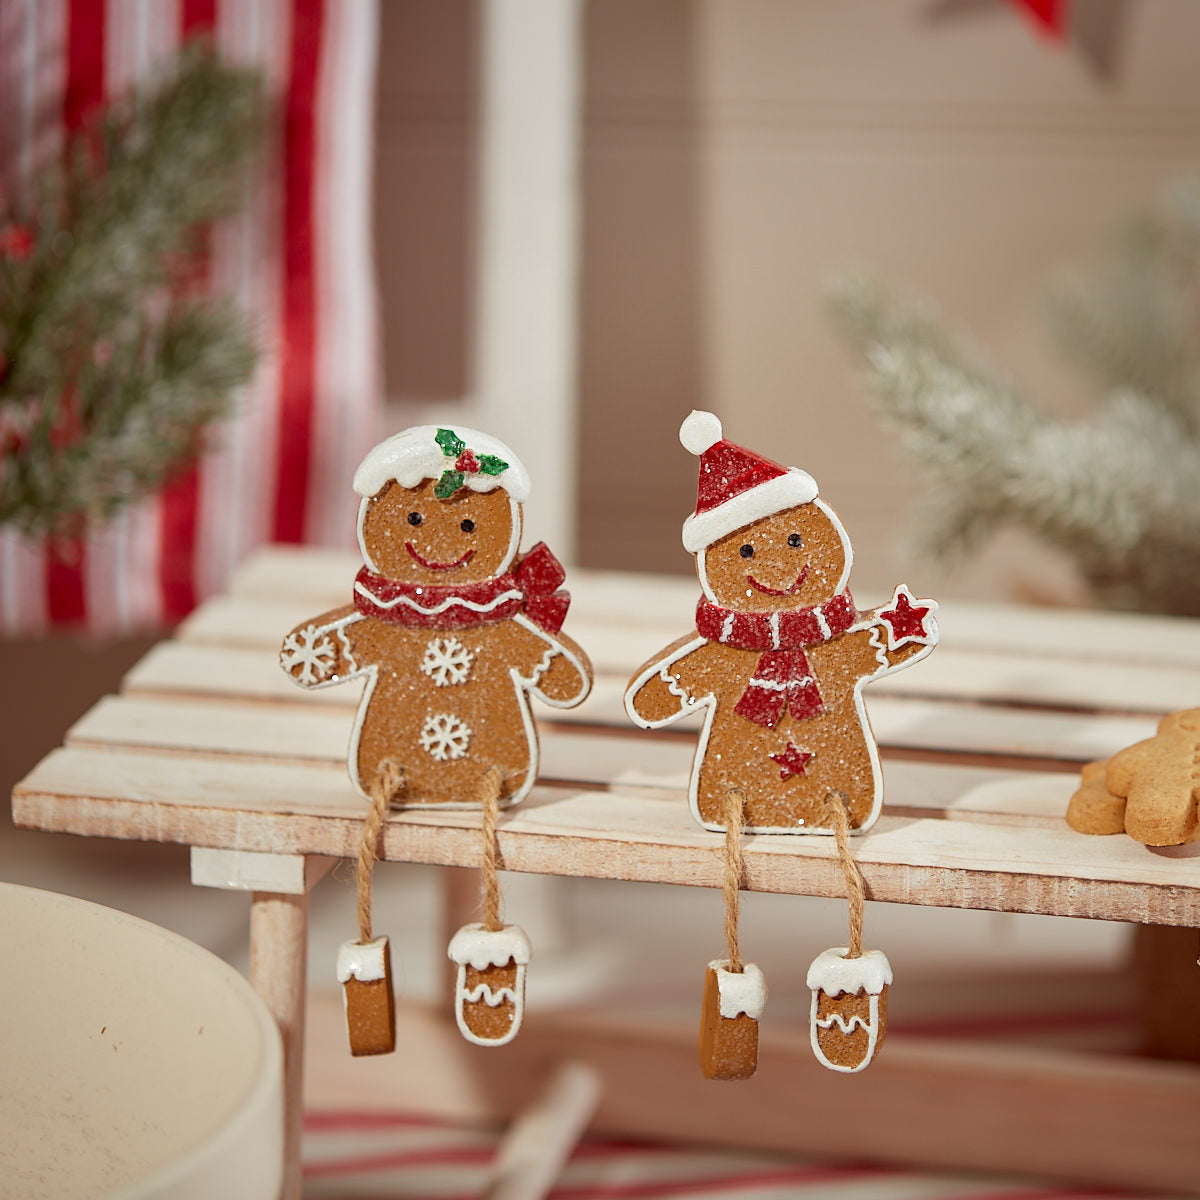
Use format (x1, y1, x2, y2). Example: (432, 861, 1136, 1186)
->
(625, 412, 937, 833)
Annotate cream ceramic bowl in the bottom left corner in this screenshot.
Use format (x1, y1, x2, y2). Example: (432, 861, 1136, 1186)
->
(0, 883, 283, 1200)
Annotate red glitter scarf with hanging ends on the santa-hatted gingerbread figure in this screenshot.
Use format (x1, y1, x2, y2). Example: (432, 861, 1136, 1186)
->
(696, 592, 858, 730)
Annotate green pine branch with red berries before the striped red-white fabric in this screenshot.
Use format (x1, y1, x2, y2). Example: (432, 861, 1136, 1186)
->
(0, 44, 265, 534)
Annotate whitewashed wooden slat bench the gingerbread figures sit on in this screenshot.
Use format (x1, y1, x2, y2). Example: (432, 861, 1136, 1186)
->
(13, 550, 1200, 1194)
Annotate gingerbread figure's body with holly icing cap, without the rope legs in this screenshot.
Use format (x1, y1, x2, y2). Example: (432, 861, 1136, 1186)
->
(280, 425, 592, 808)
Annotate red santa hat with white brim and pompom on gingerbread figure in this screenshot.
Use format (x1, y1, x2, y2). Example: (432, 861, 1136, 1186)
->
(679, 409, 817, 554)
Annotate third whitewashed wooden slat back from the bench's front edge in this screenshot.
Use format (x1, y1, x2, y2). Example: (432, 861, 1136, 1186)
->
(117, 642, 1154, 763)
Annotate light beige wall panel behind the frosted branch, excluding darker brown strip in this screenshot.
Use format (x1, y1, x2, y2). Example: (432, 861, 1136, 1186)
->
(676, 0, 1200, 599)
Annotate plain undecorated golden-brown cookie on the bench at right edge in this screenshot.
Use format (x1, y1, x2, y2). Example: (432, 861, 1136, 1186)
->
(1067, 708, 1200, 846)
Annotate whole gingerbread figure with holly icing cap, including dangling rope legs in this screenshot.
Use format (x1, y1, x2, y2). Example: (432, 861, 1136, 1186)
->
(280, 426, 592, 1054)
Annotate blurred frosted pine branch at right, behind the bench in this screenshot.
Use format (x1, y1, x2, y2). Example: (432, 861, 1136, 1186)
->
(830, 268, 1200, 613)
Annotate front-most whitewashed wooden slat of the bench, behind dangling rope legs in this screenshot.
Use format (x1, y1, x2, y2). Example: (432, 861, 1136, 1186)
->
(13, 749, 1200, 925)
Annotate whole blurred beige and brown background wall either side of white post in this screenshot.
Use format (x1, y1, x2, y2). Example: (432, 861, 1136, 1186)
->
(377, 0, 1200, 602)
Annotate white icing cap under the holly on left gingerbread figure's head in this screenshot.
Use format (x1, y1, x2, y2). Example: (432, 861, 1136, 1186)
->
(354, 425, 529, 504)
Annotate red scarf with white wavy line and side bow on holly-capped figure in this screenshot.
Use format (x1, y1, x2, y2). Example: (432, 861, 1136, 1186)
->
(354, 541, 571, 634)
